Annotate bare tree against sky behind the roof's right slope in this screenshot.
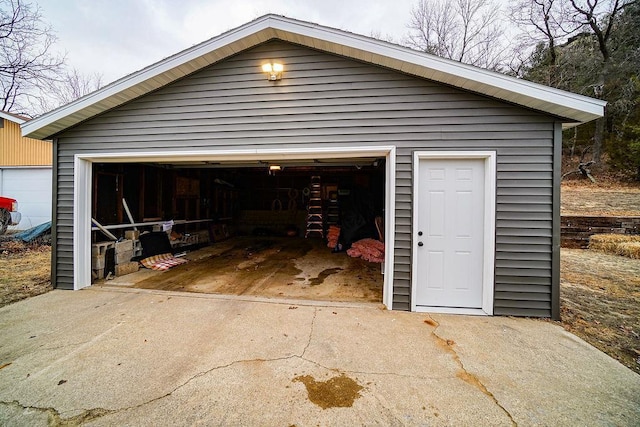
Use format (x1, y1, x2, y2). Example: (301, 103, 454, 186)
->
(405, 0, 505, 70)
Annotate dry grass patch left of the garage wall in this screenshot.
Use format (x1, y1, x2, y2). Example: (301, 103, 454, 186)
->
(0, 240, 52, 307)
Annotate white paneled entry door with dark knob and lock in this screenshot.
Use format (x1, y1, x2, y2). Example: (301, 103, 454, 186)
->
(413, 158, 493, 312)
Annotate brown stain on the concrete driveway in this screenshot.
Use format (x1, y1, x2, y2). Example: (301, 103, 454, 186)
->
(293, 374, 363, 409)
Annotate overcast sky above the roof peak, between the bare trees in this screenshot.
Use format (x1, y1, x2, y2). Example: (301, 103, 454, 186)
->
(34, 0, 418, 84)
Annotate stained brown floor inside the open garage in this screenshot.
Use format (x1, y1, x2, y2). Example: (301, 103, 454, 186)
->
(102, 237, 383, 303)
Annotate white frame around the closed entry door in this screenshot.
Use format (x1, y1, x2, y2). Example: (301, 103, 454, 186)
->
(411, 151, 497, 316)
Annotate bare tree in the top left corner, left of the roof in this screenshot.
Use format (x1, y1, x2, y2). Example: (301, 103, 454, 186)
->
(0, 0, 65, 115)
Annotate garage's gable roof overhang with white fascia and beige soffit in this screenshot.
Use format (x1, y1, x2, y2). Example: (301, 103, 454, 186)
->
(22, 15, 606, 139)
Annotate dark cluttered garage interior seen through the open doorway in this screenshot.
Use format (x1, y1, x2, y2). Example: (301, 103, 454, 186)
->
(91, 157, 386, 303)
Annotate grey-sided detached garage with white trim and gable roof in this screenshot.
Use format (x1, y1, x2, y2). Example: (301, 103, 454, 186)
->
(23, 15, 604, 318)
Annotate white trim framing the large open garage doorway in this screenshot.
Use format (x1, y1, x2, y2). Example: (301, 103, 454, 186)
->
(73, 145, 396, 310)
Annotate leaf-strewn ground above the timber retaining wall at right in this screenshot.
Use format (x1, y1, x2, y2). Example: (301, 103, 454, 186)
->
(560, 182, 640, 216)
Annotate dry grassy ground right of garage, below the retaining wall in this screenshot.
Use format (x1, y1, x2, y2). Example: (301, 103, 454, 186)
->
(560, 249, 640, 373)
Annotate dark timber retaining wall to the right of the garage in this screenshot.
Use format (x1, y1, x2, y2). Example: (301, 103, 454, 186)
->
(560, 215, 640, 249)
